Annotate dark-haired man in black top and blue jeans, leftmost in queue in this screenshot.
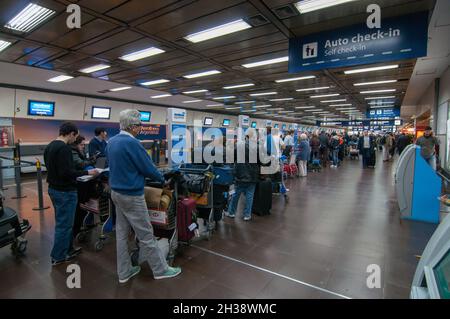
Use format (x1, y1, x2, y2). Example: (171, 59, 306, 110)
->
(44, 122, 98, 266)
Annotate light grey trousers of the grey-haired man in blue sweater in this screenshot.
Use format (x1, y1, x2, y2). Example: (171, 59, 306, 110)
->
(111, 191, 168, 279)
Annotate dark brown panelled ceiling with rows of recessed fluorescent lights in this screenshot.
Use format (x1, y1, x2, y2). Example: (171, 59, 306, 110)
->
(0, 0, 434, 122)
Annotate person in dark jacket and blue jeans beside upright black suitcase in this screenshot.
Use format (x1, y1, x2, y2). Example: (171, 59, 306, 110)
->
(226, 129, 260, 221)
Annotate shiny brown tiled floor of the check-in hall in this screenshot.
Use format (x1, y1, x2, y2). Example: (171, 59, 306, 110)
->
(0, 152, 435, 298)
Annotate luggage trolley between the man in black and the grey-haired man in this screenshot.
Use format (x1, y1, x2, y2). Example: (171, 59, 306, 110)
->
(76, 177, 114, 251)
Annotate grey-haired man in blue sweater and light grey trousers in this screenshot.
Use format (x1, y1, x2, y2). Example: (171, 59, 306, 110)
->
(106, 109, 181, 283)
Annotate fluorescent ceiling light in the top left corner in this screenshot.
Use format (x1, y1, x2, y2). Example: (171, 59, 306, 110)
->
(5, 3, 56, 32)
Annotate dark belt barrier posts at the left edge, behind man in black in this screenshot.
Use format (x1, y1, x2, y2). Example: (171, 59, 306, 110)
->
(0, 156, 50, 211)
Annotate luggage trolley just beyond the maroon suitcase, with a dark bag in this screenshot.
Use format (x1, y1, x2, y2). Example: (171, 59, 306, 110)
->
(178, 164, 215, 240)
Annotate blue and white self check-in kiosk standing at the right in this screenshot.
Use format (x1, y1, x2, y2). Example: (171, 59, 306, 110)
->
(395, 145, 442, 223)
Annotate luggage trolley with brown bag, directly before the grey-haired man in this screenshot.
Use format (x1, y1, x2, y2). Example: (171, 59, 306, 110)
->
(131, 177, 178, 266)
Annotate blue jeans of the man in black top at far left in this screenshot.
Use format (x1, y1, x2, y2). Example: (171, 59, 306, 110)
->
(48, 188, 78, 261)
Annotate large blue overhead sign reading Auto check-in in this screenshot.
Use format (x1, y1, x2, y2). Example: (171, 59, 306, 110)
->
(289, 12, 428, 73)
